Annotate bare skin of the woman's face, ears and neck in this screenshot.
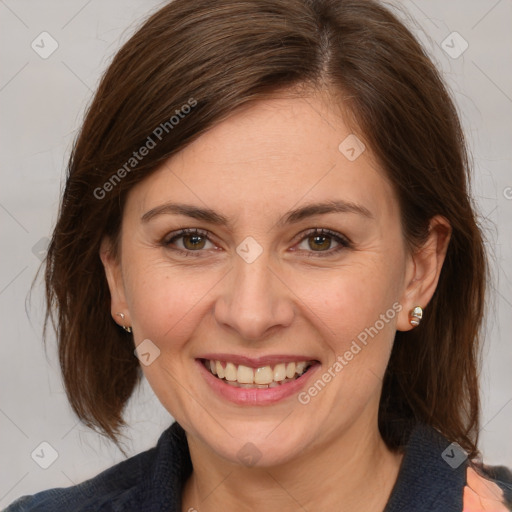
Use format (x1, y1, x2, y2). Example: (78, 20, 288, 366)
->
(101, 93, 450, 512)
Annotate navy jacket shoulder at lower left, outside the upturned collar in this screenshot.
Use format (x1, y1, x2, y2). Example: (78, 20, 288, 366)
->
(4, 448, 156, 512)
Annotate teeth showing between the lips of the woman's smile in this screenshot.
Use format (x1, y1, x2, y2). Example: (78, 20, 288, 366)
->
(201, 359, 318, 389)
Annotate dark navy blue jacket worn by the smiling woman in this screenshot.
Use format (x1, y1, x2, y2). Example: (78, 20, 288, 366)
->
(4, 422, 512, 512)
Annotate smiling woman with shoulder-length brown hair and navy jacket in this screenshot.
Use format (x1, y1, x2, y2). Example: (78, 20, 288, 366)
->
(8, 0, 512, 512)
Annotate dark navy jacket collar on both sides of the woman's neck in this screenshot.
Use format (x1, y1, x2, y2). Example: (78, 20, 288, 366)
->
(132, 422, 468, 512)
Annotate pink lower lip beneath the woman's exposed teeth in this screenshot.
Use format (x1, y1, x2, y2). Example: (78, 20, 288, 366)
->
(196, 359, 320, 405)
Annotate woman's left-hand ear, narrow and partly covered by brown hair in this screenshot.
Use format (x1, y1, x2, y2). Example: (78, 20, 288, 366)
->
(100, 237, 131, 327)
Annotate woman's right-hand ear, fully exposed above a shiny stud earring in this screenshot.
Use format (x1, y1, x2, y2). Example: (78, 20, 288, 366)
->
(396, 215, 452, 331)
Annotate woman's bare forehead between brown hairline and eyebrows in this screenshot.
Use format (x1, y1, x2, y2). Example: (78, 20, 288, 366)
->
(129, 96, 396, 226)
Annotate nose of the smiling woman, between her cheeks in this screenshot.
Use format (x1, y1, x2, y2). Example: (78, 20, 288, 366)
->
(215, 247, 295, 341)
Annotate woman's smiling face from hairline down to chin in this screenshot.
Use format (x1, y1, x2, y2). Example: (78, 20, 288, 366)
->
(104, 92, 428, 466)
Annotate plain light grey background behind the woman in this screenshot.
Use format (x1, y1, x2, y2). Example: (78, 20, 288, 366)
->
(0, 0, 512, 507)
